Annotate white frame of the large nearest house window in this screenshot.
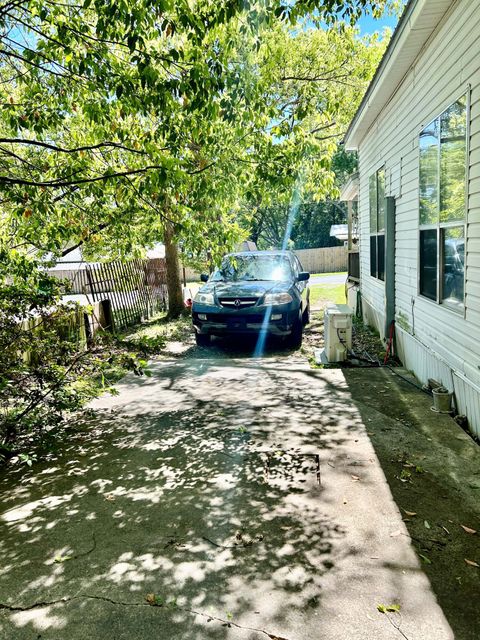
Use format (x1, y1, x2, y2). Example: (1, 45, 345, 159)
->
(417, 89, 471, 317)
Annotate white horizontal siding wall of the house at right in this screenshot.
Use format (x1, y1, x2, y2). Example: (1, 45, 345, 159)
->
(359, 0, 480, 435)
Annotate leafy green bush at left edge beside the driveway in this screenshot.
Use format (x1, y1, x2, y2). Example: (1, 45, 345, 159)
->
(0, 251, 146, 459)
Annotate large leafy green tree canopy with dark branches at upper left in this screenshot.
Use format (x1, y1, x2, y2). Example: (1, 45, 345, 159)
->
(0, 0, 394, 292)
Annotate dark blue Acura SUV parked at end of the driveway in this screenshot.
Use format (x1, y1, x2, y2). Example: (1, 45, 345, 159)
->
(192, 251, 310, 347)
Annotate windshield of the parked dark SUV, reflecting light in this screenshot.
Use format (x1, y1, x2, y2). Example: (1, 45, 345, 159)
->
(210, 254, 292, 282)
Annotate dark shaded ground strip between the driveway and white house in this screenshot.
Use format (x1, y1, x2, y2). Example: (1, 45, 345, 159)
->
(344, 369, 480, 640)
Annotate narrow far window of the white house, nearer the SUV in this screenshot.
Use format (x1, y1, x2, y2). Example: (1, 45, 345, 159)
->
(369, 169, 385, 280)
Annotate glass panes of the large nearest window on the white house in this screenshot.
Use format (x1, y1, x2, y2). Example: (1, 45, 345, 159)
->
(419, 95, 467, 308)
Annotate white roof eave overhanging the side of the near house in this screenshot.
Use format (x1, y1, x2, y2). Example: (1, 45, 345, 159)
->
(344, 0, 455, 150)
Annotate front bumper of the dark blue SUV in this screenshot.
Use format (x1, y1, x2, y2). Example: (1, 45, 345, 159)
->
(192, 304, 298, 336)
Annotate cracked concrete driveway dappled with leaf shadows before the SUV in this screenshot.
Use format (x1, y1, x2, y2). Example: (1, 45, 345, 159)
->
(0, 358, 462, 640)
